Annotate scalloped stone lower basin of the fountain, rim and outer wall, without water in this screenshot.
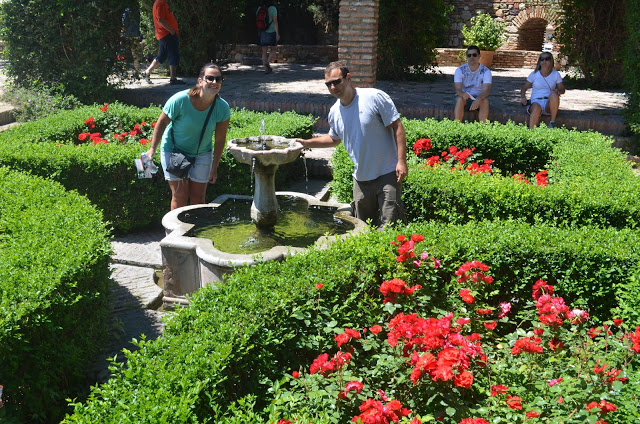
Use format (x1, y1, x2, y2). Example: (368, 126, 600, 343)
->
(160, 192, 367, 308)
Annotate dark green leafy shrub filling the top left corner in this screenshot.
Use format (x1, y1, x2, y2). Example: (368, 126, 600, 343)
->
(0, 0, 129, 103)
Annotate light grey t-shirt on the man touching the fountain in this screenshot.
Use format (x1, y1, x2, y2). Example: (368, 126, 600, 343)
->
(329, 88, 400, 181)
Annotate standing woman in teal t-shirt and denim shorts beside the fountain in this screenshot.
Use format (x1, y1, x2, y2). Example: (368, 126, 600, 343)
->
(146, 63, 231, 210)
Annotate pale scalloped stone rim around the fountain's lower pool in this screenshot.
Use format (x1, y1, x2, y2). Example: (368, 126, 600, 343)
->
(160, 191, 368, 267)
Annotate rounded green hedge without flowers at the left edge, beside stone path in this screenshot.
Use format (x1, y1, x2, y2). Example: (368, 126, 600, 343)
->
(0, 167, 111, 423)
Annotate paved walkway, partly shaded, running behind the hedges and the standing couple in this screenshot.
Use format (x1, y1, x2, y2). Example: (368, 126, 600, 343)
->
(119, 63, 626, 135)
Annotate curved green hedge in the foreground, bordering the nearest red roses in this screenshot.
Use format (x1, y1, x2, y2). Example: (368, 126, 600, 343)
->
(65, 222, 640, 424)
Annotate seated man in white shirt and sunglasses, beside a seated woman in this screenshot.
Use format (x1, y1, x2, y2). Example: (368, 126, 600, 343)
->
(453, 46, 491, 122)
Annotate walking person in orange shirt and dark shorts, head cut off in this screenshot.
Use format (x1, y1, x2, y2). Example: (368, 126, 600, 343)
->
(144, 0, 184, 84)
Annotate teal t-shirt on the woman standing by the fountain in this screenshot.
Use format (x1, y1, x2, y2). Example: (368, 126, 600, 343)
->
(160, 90, 231, 156)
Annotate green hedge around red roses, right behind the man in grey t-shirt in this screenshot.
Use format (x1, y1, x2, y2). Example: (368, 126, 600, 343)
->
(333, 119, 640, 228)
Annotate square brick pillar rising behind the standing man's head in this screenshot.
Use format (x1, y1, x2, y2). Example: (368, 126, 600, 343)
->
(338, 0, 379, 87)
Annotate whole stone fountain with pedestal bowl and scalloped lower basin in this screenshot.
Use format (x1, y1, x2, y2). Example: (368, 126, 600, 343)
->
(160, 136, 366, 307)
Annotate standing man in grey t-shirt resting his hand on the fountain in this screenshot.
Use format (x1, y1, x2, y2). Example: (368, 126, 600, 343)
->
(298, 62, 408, 227)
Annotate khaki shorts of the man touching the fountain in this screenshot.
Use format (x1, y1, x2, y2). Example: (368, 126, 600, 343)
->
(351, 171, 406, 228)
